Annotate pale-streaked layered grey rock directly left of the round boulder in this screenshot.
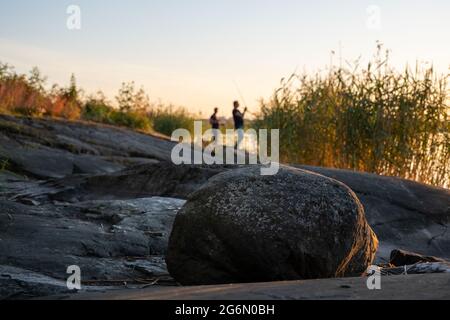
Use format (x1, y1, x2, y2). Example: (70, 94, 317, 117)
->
(0, 198, 184, 298)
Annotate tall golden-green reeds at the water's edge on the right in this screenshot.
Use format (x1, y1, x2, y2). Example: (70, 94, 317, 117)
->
(255, 46, 450, 186)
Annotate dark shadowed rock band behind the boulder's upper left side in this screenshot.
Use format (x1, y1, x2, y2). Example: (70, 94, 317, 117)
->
(37, 162, 232, 202)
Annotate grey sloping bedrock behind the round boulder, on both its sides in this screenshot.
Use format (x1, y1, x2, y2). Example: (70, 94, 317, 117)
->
(0, 115, 450, 298)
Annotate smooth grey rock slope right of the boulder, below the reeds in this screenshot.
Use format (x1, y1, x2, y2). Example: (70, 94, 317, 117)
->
(301, 166, 450, 264)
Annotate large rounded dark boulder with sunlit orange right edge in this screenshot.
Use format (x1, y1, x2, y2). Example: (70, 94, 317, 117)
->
(166, 166, 378, 285)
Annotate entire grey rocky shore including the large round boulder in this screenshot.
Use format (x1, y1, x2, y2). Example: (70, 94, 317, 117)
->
(0, 116, 450, 299)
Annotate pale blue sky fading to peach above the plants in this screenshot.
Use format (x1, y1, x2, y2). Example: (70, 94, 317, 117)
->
(0, 0, 450, 114)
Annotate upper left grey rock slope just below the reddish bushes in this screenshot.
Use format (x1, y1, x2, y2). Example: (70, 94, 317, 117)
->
(0, 115, 175, 179)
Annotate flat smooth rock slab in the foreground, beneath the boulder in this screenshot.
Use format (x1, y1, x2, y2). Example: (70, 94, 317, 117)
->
(59, 273, 450, 300)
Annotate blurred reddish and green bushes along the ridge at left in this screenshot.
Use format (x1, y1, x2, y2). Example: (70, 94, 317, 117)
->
(0, 63, 197, 136)
